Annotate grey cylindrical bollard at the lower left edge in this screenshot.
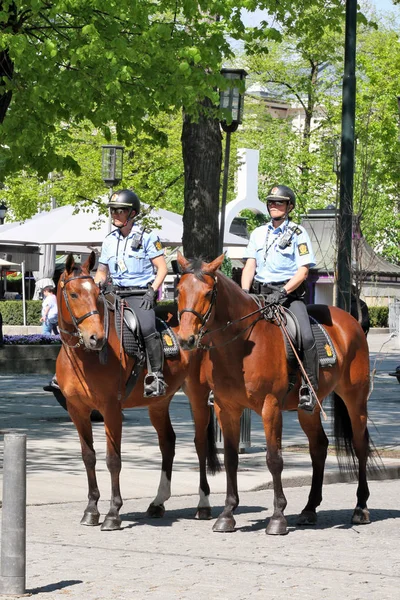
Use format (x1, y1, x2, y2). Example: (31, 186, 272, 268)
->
(0, 433, 26, 596)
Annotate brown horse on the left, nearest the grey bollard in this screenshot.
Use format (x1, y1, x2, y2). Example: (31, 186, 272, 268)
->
(56, 253, 219, 531)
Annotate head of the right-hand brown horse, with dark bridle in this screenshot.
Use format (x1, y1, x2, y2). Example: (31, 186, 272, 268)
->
(177, 252, 224, 350)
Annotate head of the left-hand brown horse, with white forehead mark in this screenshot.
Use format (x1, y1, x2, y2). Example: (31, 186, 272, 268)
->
(57, 252, 105, 350)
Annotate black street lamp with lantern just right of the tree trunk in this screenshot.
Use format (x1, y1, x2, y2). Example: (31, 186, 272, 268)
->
(218, 69, 247, 254)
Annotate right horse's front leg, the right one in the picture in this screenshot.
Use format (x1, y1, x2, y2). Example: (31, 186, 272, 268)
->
(262, 396, 288, 535)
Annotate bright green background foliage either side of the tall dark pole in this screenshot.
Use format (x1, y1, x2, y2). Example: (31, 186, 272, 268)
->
(237, 10, 400, 262)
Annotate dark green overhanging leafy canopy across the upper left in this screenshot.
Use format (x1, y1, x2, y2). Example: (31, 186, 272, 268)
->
(0, 0, 343, 180)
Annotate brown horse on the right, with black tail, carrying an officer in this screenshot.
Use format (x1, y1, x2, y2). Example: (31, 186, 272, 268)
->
(178, 255, 371, 535)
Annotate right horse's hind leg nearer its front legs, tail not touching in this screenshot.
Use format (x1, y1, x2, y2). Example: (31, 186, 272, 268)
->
(297, 410, 329, 525)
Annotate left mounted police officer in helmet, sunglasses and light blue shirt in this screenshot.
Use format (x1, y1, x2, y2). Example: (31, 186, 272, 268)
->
(95, 190, 168, 397)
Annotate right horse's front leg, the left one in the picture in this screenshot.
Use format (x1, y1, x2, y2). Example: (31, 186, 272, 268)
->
(213, 403, 242, 533)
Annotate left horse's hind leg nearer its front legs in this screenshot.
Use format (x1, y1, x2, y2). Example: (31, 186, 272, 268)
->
(147, 396, 176, 518)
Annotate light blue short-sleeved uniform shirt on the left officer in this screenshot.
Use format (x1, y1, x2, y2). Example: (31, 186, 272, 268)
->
(99, 225, 164, 288)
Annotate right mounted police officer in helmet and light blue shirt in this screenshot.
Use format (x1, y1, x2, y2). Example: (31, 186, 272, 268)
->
(242, 185, 319, 412)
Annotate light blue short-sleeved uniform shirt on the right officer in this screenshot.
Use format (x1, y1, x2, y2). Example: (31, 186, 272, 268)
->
(244, 220, 315, 283)
